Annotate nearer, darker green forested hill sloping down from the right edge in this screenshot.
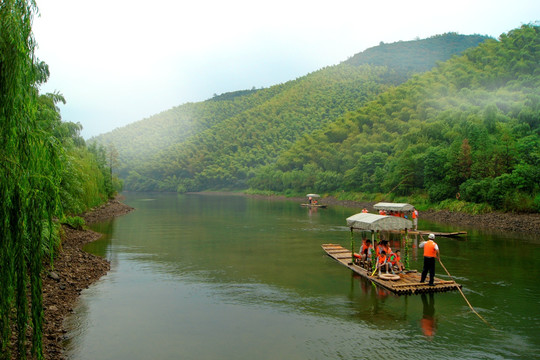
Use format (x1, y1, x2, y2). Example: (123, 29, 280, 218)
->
(250, 25, 540, 212)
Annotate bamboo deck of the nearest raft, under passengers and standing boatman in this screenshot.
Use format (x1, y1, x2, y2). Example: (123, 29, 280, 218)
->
(322, 244, 461, 295)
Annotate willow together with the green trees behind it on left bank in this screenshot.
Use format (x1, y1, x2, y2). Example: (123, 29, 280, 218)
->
(0, 0, 119, 359)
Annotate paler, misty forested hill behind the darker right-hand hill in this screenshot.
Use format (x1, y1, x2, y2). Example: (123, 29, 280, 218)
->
(91, 34, 486, 191)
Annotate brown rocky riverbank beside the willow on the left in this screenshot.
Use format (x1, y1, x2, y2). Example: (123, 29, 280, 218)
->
(42, 198, 133, 360)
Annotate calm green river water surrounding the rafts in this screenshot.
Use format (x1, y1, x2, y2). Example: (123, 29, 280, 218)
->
(67, 194, 540, 360)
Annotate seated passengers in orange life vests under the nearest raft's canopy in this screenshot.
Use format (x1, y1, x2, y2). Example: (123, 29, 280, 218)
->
(354, 239, 405, 274)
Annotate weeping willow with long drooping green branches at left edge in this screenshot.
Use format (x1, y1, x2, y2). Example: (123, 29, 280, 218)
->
(0, 0, 60, 359)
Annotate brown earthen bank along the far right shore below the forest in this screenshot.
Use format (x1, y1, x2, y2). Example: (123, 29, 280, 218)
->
(248, 195, 540, 234)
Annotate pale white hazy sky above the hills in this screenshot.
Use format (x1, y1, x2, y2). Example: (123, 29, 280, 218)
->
(33, 0, 540, 138)
